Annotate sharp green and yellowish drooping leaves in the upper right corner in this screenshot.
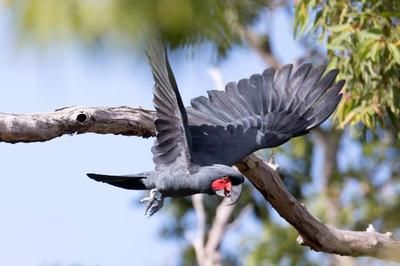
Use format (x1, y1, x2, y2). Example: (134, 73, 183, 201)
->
(295, 0, 400, 131)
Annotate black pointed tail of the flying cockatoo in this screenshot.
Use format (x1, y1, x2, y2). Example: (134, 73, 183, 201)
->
(87, 173, 151, 190)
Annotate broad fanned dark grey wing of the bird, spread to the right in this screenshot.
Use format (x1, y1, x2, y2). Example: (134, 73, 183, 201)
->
(186, 64, 344, 165)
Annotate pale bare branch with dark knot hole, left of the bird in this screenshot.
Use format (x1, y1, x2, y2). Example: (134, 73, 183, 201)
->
(0, 106, 154, 143)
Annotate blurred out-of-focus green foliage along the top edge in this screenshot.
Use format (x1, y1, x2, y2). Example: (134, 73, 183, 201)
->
(10, 0, 269, 54)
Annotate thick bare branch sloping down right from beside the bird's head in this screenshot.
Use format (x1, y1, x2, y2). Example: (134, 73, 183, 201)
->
(237, 155, 400, 261)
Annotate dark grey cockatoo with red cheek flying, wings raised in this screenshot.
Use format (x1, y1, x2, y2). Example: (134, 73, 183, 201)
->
(87, 38, 344, 216)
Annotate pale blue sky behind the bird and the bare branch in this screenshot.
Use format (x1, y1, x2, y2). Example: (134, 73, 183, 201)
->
(0, 6, 301, 266)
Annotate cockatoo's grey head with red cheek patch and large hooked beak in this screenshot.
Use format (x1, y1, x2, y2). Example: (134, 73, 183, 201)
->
(205, 165, 244, 204)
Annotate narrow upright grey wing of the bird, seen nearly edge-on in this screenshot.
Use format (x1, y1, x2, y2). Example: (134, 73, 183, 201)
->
(147, 36, 191, 170)
